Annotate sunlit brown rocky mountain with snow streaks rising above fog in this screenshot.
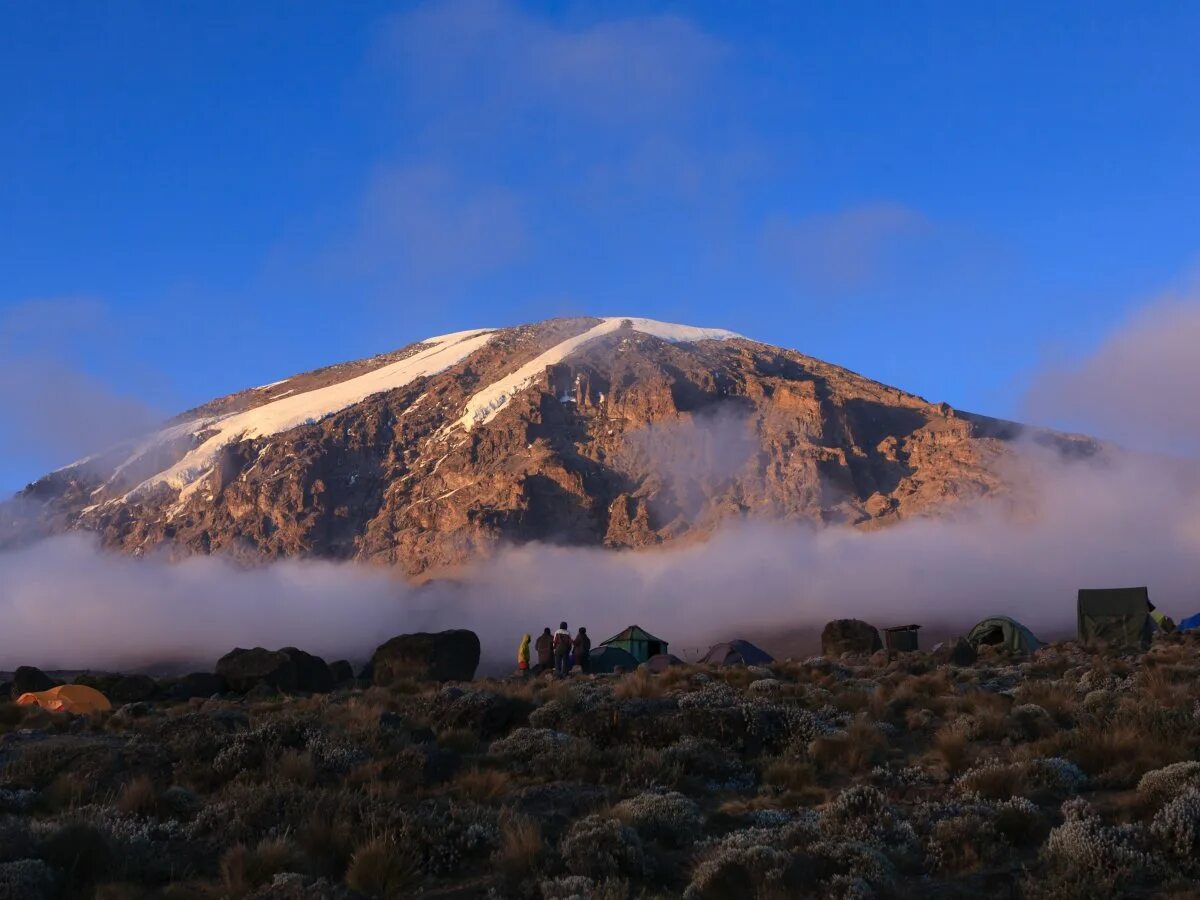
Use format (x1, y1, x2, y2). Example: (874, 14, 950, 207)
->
(6, 318, 1094, 575)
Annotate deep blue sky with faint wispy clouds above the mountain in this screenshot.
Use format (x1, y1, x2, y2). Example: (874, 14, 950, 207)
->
(0, 0, 1200, 490)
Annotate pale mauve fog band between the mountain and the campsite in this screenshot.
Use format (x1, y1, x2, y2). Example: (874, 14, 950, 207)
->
(0, 449, 1200, 670)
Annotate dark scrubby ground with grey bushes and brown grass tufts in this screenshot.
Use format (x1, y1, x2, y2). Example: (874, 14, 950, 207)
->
(0, 635, 1200, 900)
